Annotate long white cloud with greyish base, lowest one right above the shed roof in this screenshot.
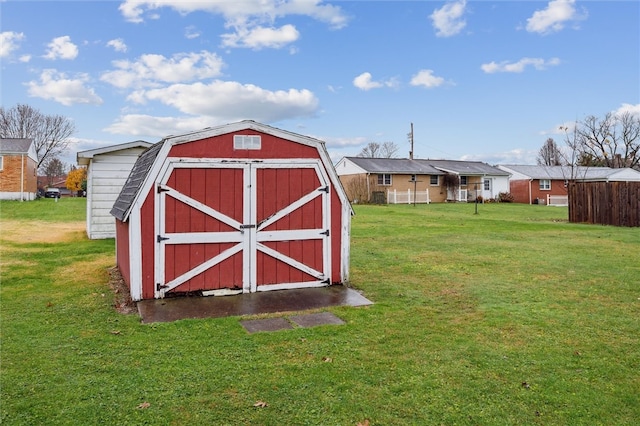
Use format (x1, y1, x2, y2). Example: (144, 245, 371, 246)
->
(129, 80, 318, 122)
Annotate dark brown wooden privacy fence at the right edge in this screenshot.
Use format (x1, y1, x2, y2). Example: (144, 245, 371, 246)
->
(569, 182, 640, 226)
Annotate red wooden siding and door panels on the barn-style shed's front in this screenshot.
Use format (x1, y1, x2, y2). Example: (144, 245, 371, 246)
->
(121, 125, 350, 300)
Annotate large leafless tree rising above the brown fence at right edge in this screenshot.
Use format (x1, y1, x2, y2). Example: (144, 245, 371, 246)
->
(577, 112, 640, 169)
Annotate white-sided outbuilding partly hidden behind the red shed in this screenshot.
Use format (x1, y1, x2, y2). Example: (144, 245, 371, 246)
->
(87, 147, 145, 239)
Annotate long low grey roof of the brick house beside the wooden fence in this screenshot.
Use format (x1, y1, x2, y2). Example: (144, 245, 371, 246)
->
(500, 164, 640, 180)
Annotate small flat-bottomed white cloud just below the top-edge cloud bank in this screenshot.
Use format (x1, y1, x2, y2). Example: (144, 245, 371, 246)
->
(222, 25, 300, 50)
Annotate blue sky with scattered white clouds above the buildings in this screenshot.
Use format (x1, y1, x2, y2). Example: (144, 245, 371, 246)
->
(0, 0, 640, 164)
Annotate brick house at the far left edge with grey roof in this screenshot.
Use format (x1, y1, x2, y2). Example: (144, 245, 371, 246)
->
(0, 138, 38, 200)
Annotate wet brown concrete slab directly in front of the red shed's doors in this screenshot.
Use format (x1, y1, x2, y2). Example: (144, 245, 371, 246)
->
(137, 285, 373, 324)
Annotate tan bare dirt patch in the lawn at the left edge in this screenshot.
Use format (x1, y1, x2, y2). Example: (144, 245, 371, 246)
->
(0, 220, 85, 243)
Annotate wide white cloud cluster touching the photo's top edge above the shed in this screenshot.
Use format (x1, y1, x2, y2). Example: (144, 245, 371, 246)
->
(119, 0, 348, 49)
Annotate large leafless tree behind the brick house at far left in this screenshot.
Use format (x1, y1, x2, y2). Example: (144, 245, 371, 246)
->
(0, 104, 76, 168)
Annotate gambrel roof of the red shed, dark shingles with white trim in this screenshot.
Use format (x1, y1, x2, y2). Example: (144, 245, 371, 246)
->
(111, 120, 353, 222)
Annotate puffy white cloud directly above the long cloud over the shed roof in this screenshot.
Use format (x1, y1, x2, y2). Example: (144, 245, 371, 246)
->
(100, 51, 224, 88)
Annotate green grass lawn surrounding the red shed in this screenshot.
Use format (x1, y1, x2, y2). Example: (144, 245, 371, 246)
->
(0, 199, 640, 425)
